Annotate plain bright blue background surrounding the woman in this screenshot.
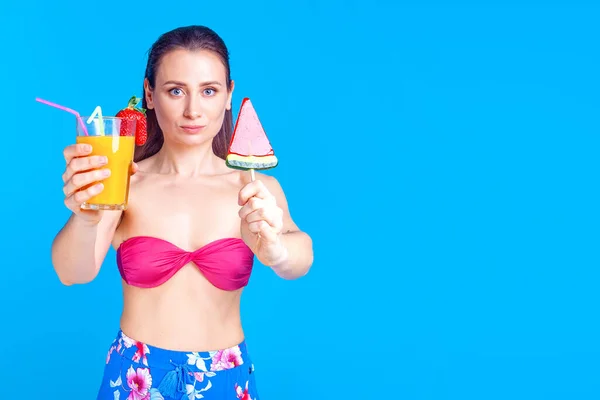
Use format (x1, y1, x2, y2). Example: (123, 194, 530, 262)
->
(0, 0, 600, 400)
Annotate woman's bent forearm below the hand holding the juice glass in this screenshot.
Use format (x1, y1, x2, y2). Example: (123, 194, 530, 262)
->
(52, 215, 98, 285)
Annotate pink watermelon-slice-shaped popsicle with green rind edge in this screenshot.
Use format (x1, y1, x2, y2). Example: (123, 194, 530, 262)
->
(225, 98, 278, 170)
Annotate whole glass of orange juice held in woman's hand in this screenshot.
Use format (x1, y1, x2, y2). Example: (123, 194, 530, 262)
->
(76, 117, 135, 210)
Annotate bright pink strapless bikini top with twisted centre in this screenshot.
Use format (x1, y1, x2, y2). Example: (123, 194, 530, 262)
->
(117, 236, 254, 290)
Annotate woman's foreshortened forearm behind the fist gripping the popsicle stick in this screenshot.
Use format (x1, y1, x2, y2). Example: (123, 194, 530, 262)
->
(270, 231, 314, 279)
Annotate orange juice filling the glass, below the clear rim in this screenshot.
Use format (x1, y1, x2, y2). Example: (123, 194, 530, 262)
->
(77, 134, 135, 210)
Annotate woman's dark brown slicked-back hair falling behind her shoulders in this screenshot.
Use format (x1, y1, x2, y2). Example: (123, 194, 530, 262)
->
(134, 25, 233, 162)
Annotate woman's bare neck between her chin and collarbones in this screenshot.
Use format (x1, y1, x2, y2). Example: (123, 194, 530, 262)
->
(154, 141, 225, 177)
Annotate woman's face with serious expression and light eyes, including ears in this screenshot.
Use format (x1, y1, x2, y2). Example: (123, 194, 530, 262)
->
(144, 49, 233, 145)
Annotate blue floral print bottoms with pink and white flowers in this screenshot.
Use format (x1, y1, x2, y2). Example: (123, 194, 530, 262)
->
(97, 331, 259, 400)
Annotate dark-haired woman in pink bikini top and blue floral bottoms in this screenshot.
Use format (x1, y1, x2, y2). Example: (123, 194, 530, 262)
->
(52, 26, 313, 400)
